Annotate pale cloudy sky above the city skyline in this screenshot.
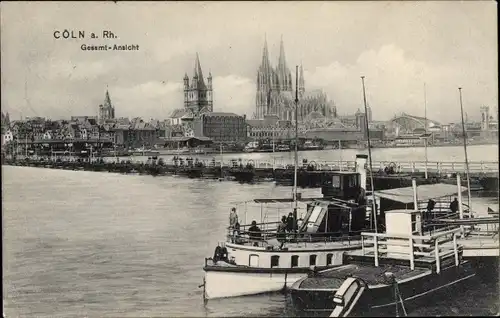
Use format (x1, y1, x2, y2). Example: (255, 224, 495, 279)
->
(0, 1, 498, 122)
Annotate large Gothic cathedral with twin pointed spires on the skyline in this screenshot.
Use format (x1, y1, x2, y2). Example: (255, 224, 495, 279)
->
(254, 39, 337, 121)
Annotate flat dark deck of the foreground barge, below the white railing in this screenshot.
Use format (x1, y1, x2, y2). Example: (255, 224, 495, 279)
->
(300, 264, 432, 290)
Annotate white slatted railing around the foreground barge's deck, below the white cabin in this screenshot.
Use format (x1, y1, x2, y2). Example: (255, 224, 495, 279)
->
(361, 227, 462, 273)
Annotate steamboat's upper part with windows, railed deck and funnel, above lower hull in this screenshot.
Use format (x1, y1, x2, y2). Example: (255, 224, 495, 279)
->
(211, 155, 371, 269)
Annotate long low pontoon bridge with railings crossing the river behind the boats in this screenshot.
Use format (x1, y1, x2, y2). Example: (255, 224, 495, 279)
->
(2, 156, 498, 191)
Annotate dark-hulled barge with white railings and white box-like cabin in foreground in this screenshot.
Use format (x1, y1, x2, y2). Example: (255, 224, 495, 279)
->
(290, 179, 475, 317)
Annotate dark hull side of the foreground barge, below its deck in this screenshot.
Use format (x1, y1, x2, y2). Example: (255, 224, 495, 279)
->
(289, 261, 476, 317)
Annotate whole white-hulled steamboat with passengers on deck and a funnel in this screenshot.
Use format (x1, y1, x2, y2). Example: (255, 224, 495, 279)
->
(199, 155, 378, 299)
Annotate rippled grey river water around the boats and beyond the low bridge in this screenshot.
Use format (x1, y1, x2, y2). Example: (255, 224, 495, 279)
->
(2, 146, 499, 317)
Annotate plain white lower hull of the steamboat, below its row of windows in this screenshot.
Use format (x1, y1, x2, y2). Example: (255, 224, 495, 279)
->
(205, 271, 307, 299)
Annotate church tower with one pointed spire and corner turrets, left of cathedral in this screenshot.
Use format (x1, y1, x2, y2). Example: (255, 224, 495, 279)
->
(184, 53, 213, 114)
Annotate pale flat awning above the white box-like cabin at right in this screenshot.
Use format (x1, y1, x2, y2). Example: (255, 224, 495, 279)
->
(375, 183, 467, 204)
